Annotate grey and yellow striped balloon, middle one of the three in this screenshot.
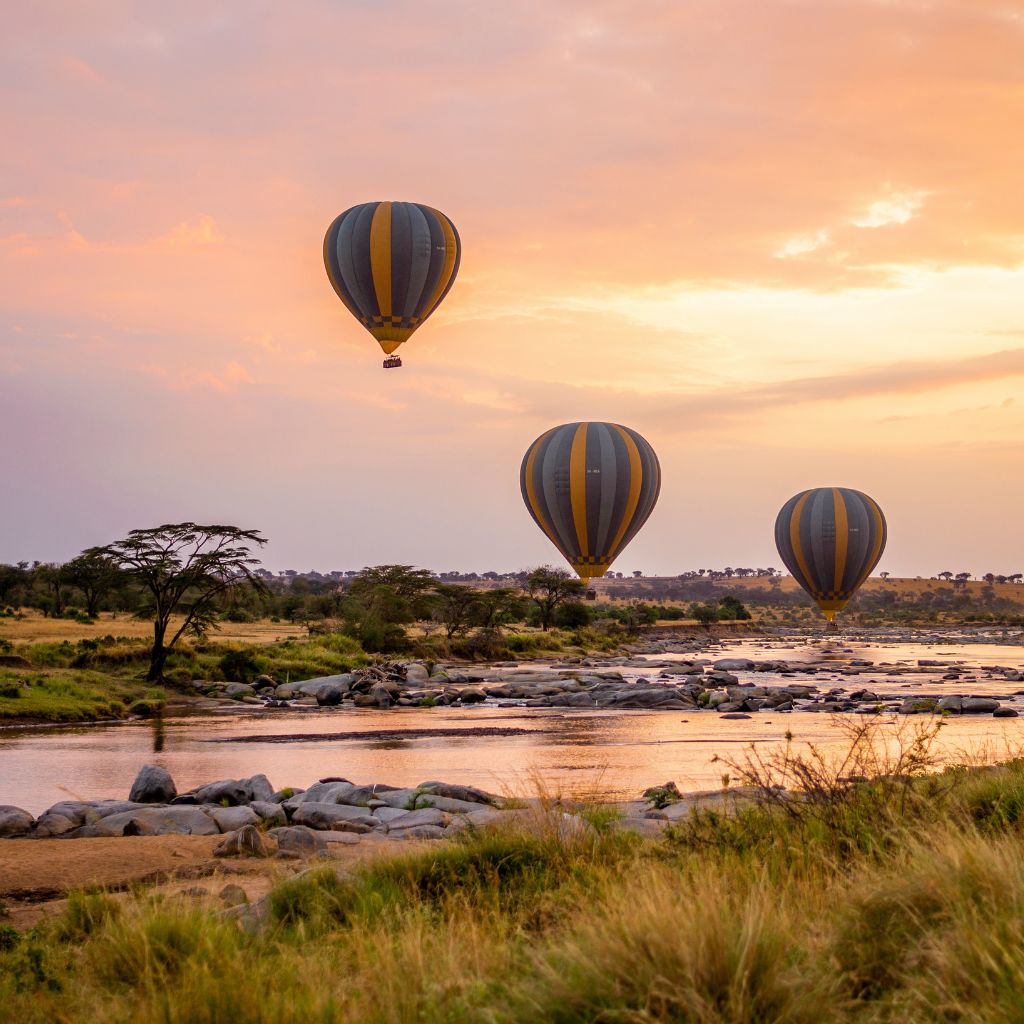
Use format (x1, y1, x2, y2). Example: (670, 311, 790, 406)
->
(519, 423, 662, 583)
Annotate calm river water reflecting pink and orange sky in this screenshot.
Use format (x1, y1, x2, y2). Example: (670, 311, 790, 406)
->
(0, 640, 1024, 814)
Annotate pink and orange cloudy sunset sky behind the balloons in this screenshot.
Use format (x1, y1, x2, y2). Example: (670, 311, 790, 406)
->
(0, 0, 1024, 575)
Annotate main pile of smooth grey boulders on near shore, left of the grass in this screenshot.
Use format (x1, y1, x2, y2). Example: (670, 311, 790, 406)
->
(0, 765, 503, 856)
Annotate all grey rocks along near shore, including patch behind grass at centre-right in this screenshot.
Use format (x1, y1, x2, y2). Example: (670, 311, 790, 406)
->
(0, 765, 746, 859)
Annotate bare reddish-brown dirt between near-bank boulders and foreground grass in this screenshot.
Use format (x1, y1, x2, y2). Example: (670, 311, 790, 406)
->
(0, 836, 424, 931)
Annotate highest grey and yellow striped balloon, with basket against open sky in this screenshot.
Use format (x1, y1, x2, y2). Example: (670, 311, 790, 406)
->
(324, 203, 462, 369)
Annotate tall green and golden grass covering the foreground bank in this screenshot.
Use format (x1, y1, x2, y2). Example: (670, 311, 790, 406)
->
(6, 749, 1024, 1024)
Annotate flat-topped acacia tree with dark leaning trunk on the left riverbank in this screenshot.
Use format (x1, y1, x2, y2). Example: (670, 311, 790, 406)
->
(83, 522, 266, 681)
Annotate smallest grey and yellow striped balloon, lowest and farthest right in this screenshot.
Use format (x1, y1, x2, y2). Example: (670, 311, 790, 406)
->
(775, 487, 886, 622)
